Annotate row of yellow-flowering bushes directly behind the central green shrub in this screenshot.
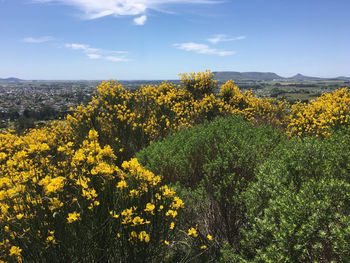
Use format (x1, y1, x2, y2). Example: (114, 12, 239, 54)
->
(67, 71, 286, 163)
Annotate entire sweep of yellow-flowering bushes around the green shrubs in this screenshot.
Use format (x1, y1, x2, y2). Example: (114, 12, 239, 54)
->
(0, 71, 350, 262)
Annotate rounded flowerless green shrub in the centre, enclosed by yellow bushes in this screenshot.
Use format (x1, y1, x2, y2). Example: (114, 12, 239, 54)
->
(137, 116, 285, 256)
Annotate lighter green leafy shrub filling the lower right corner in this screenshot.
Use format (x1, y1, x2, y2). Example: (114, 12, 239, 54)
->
(236, 130, 350, 262)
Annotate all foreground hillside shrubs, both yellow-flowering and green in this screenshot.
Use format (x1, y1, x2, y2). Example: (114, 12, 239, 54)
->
(0, 71, 350, 262)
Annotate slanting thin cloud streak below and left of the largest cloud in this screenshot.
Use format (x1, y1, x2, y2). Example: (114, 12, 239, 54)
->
(64, 43, 129, 62)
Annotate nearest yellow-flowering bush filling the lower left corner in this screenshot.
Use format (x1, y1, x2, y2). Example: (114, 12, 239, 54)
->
(0, 125, 184, 262)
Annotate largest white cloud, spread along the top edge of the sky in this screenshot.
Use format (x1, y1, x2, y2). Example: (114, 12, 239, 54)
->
(32, 0, 221, 25)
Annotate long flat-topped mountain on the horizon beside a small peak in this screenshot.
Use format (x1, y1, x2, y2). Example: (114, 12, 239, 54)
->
(213, 71, 283, 81)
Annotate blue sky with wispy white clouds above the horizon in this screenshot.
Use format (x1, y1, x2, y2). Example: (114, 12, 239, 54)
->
(0, 0, 350, 80)
